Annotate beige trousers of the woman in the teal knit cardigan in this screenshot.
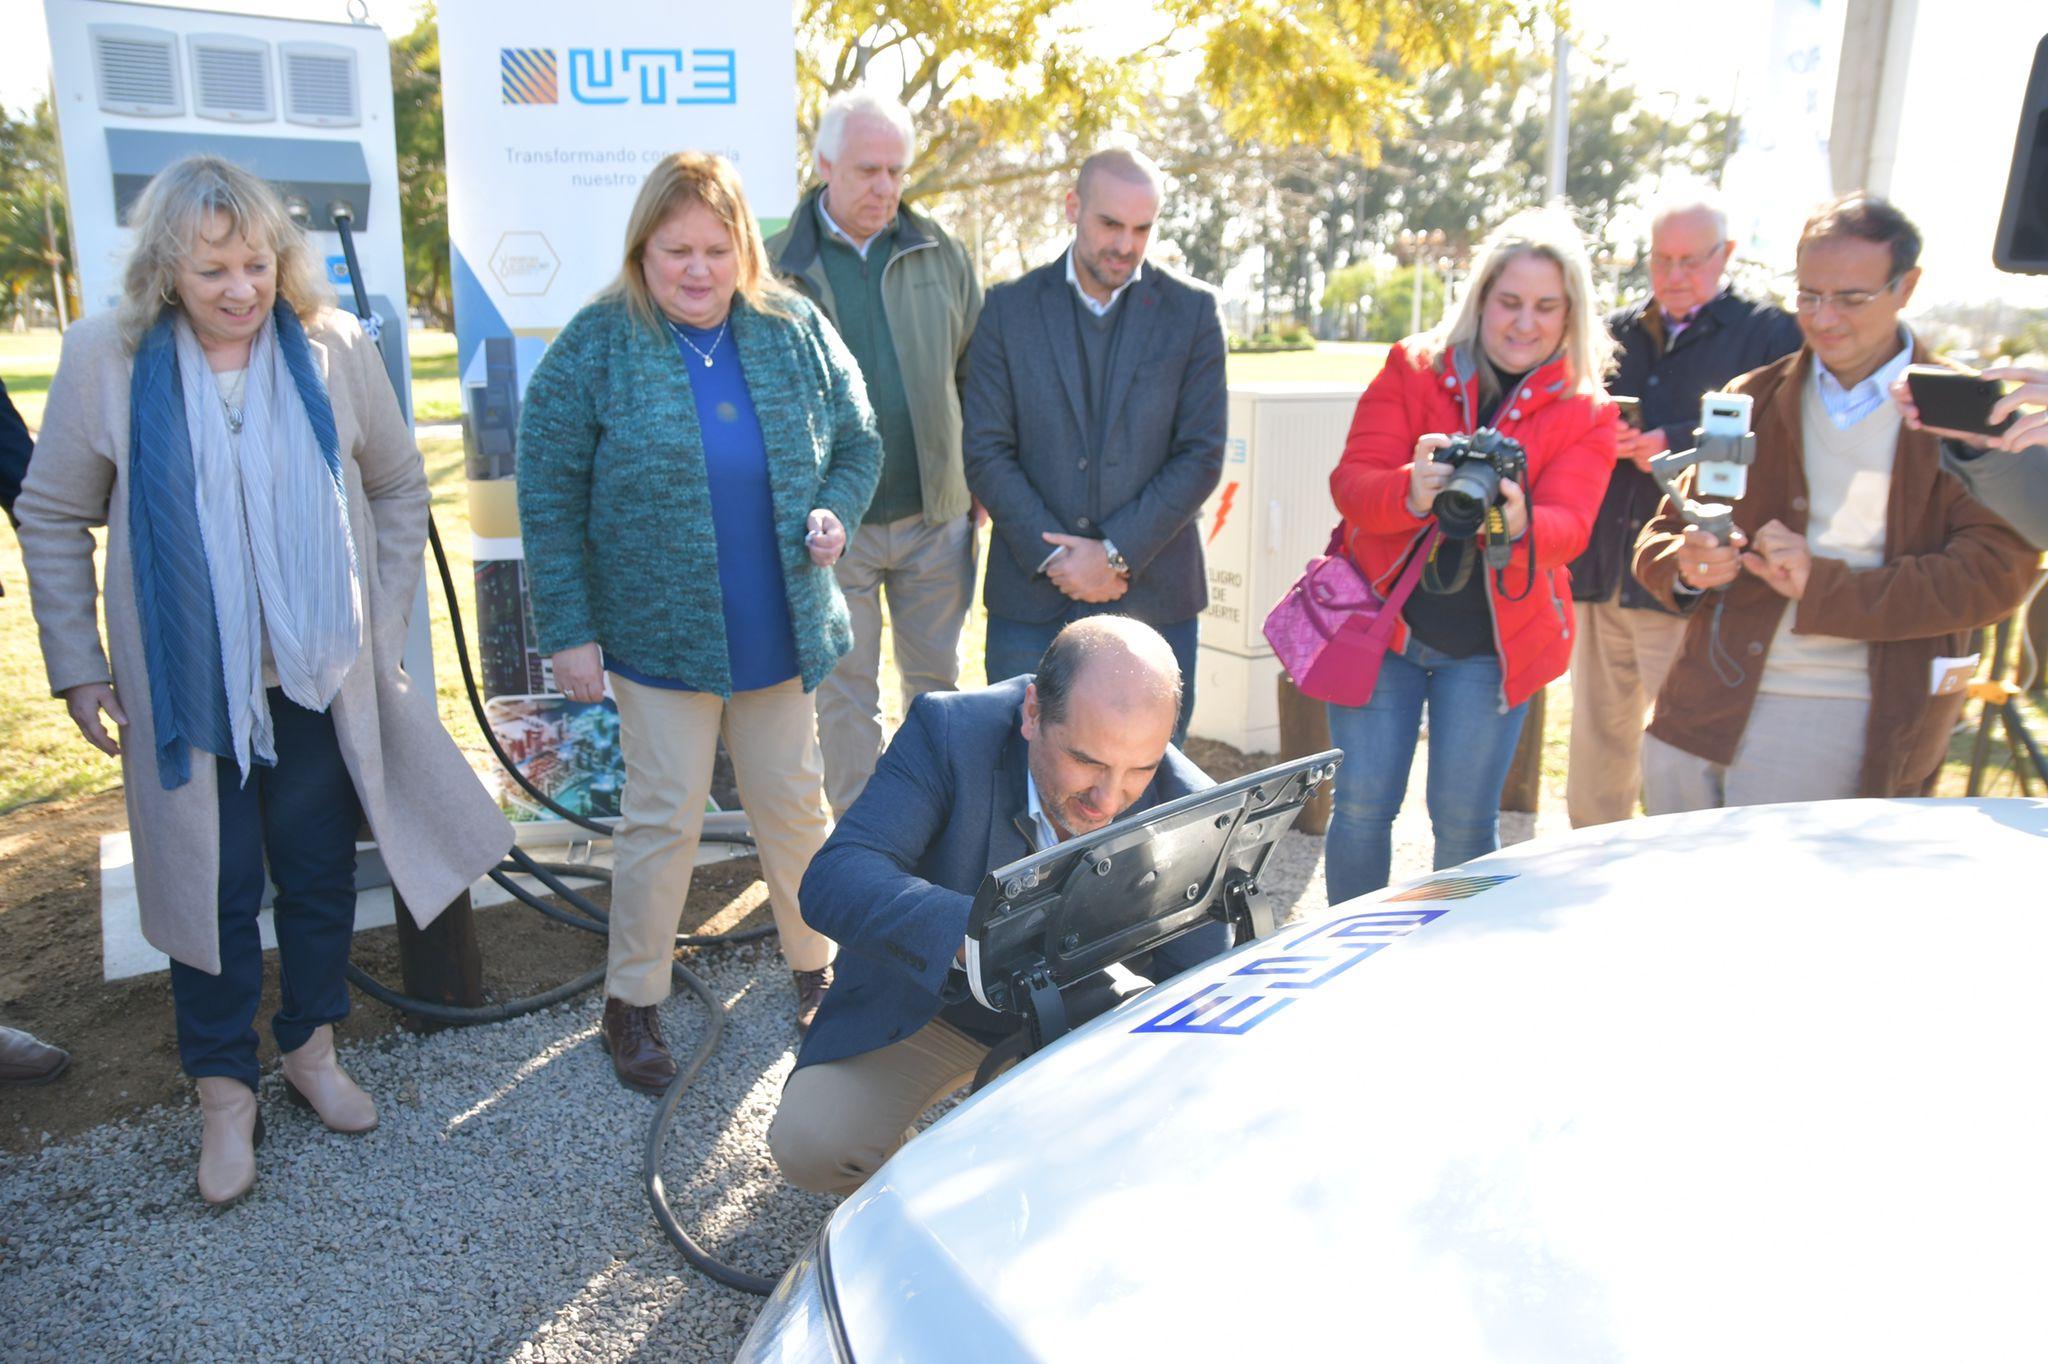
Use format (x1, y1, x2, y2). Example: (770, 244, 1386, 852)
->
(604, 672, 834, 1006)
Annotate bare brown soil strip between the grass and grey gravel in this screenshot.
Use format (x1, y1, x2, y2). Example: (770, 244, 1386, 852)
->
(0, 739, 1272, 1151)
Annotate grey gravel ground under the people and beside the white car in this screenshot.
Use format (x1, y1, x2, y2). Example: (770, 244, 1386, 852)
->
(0, 790, 1561, 1364)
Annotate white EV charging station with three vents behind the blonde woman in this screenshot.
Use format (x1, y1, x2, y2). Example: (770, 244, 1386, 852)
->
(45, 0, 434, 979)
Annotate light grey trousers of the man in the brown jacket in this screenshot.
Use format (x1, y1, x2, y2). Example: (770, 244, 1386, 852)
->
(1642, 692, 1870, 815)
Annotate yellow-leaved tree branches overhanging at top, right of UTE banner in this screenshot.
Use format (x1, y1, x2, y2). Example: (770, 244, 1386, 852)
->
(797, 0, 1534, 195)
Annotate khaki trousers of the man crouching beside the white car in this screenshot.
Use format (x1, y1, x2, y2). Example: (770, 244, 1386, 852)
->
(768, 1018, 989, 1194)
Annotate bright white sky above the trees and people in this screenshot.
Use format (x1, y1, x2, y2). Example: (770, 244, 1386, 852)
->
(0, 0, 2048, 307)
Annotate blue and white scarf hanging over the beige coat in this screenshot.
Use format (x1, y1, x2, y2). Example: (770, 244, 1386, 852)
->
(129, 303, 362, 788)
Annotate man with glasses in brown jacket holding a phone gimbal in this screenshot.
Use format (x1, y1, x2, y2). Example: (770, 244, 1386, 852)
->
(1634, 195, 2038, 802)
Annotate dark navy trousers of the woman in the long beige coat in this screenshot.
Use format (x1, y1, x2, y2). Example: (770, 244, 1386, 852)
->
(170, 686, 362, 1090)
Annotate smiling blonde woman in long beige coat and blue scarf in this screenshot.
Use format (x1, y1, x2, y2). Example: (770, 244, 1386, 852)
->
(14, 158, 512, 1204)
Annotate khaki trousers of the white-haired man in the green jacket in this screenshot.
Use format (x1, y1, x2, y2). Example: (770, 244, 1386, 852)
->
(817, 507, 975, 817)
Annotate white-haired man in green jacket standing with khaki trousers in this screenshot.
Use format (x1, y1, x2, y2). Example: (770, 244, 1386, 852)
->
(768, 90, 981, 815)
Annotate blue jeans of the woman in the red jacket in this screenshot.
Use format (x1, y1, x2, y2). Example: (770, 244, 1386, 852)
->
(1323, 637, 1528, 905)
